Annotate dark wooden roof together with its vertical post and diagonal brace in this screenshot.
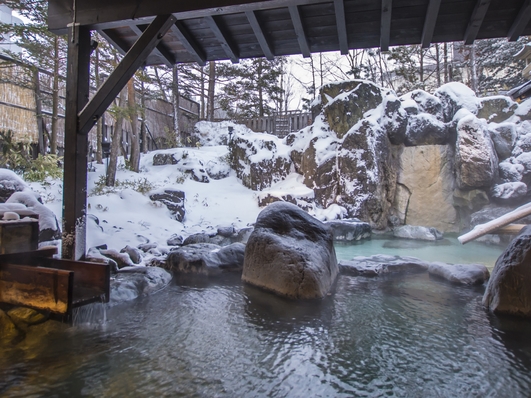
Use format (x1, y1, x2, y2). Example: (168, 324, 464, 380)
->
(48, 0, 531, 260)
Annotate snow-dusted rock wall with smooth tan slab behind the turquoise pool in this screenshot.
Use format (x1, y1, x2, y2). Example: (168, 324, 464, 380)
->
(231, 80, 531, 232)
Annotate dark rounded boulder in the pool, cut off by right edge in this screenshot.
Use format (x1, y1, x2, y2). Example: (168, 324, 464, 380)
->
(483, 226, 531, 318)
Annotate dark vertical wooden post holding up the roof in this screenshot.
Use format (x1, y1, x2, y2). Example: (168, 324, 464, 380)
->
(62, 25, 90, 260)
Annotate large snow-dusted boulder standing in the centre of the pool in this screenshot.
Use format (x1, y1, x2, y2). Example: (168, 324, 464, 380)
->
(242, 202, 338, 299)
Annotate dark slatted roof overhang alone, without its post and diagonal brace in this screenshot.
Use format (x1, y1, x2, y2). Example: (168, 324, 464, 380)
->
(48, 0, 531, 65)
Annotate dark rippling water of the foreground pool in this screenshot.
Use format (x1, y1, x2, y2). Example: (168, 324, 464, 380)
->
(0, 274, 531, 398)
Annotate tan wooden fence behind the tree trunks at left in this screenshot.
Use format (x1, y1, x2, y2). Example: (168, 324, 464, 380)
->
(0, 55, 199, 154)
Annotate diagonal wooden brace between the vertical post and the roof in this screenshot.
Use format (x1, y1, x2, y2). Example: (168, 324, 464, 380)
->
(78, 14, 176, 134)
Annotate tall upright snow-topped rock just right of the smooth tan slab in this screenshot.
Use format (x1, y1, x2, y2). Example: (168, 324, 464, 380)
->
(456, 115, 498, 189)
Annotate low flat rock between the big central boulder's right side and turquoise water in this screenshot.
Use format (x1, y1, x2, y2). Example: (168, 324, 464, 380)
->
(339, 254, 428, 276)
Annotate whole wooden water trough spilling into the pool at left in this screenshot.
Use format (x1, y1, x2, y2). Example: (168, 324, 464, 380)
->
(0, 211, 110, 320)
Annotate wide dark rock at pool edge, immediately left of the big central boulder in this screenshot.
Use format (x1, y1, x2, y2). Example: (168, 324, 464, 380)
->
(167, 243, 245, 276)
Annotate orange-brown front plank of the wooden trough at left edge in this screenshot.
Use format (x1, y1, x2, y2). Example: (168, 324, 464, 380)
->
(0, 264, 74, 314)
